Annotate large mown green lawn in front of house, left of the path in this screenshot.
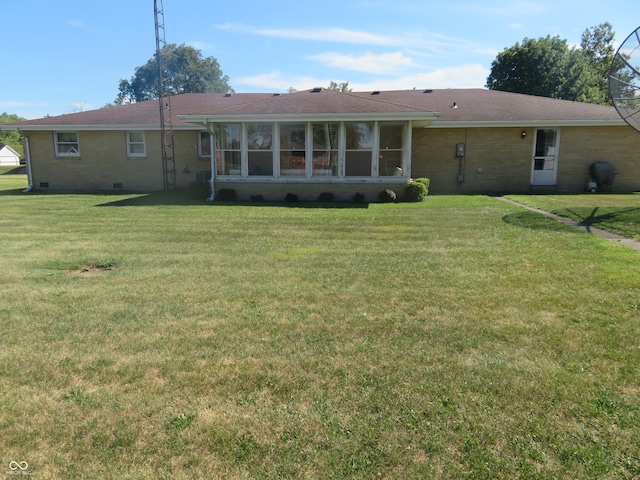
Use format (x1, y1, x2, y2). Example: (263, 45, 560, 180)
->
(0, 175, 640, 479)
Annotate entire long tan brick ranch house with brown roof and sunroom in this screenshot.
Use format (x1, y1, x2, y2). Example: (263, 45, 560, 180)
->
(3, 88, 640, 200)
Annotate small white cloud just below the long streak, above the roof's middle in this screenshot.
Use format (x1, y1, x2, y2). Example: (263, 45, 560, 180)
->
(309, 52, 415, 75)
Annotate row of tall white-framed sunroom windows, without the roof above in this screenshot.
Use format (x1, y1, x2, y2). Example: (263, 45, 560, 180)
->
(199, 121, 422, 181)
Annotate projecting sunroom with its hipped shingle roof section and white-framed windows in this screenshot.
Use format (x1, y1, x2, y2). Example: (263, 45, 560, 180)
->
(179, 89, 439, 196)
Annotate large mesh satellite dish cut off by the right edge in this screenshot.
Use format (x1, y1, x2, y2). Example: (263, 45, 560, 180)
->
(609, 27, 640, 132)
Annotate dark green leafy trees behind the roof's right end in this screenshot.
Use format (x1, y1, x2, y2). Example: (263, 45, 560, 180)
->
(486, 23, 615, 104)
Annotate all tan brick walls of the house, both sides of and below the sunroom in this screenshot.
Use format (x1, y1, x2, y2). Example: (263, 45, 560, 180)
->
(23, 126, 640, 195)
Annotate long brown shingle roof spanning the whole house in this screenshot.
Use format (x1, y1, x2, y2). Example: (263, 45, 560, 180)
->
(5, 89, 624, 129)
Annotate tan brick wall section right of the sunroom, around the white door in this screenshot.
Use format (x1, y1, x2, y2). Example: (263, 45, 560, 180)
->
(411, 126, 640, 194)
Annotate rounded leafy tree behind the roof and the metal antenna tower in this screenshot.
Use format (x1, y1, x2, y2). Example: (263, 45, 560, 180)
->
(115, 43, 231, 105)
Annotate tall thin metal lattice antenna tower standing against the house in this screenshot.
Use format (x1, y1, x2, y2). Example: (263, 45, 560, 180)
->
(153, 0, 177, 190)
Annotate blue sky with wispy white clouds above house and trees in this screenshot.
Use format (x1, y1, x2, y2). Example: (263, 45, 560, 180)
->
(0, 0, 640, 119)
